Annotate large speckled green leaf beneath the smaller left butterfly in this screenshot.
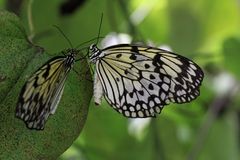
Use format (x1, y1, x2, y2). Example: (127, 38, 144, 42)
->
(0, 11, 92, 160)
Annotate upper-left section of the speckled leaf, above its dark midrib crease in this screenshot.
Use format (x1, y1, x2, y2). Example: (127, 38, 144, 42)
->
(0, 12, 31, 101)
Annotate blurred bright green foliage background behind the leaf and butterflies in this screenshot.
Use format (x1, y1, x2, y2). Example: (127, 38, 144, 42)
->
(0, 0, 240, 160)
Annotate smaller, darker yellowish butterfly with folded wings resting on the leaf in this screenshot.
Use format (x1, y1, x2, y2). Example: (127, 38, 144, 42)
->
(16, 49, 79, 130)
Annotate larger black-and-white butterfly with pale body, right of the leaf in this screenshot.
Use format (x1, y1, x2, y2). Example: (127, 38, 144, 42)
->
(89, 44, 204, 118)
